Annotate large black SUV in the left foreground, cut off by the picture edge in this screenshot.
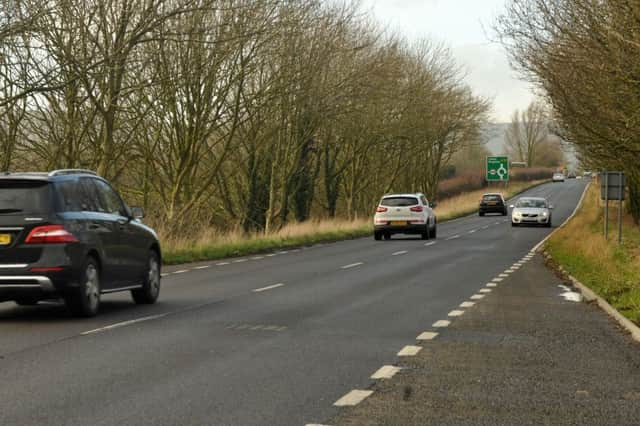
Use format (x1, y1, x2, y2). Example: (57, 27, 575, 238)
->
(0, 170, 161, 316)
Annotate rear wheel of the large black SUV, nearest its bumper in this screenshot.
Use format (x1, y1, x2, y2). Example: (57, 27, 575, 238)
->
(64, 256, 100, 317)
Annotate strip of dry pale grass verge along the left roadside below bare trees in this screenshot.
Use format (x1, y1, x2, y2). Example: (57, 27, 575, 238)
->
(162, 181, 544, 265)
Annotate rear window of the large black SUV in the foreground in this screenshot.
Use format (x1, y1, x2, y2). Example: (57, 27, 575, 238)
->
(0, 179, 50, 215)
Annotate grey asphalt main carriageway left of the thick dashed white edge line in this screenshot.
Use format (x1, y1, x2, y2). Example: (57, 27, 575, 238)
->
(0, 180, 586, 425)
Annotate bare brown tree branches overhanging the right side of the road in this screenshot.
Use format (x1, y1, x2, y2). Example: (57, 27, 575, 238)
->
(496, 0, 640, 222)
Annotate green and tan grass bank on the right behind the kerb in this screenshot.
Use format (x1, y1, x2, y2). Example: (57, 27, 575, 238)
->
(546, 185, 640, 325)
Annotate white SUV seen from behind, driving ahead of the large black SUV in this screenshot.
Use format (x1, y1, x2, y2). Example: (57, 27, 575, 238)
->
(373, 193, 437, 240)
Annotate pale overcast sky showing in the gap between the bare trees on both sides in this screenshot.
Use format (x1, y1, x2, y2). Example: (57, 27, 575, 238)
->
(362, 0, 533, 122)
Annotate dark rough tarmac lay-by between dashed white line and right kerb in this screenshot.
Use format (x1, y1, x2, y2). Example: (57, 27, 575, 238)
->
(325, 255, 640, 425)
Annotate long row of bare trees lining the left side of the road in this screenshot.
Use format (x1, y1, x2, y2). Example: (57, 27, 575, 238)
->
(0, 0, 489, 233)
